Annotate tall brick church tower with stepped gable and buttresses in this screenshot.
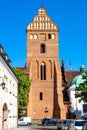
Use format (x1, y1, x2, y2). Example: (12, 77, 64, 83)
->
(26, 7, 66, 119)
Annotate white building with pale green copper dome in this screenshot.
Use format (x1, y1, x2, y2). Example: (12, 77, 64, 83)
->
(69, 65, 86, 118)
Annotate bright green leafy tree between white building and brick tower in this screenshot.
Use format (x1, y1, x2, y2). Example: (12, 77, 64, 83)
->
(13, 68, 31, 116)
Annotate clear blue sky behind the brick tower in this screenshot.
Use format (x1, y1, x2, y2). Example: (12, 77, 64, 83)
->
(0, 0, 87, 70)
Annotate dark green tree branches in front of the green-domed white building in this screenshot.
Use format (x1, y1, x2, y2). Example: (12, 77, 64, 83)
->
(75, 75, 87, 102)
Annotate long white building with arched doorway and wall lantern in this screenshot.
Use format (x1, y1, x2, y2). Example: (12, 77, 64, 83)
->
(0, 45, 18, 130)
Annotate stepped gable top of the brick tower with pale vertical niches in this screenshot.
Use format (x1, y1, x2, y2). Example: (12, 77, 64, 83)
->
(27, 7, 58, 30)
